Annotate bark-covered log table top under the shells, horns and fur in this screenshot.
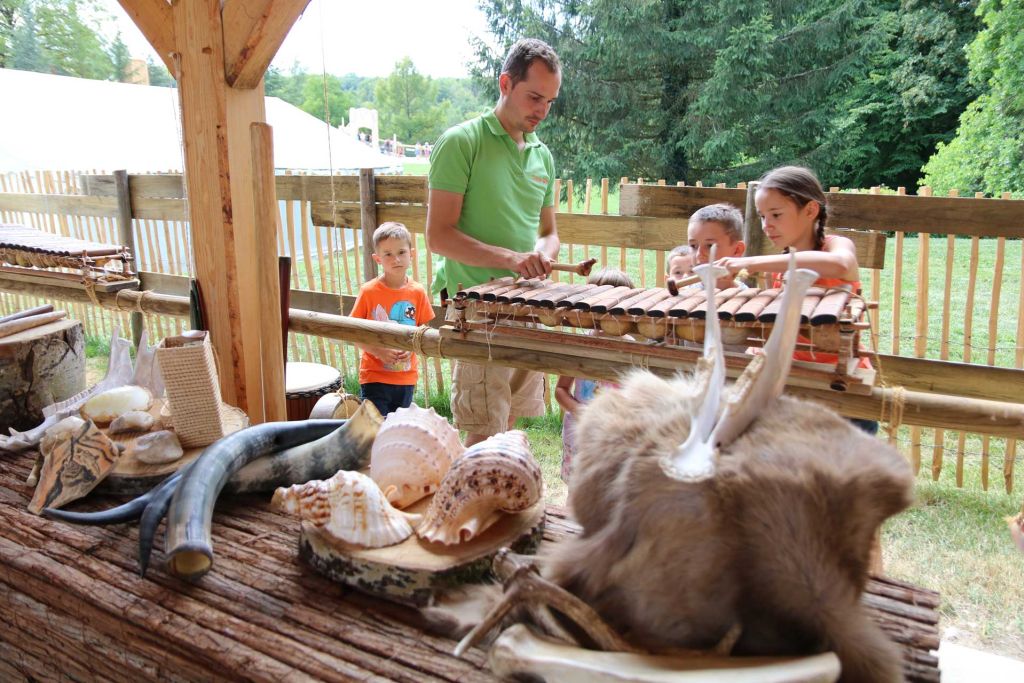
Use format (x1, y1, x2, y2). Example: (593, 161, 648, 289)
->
(0, 453, 939, 682)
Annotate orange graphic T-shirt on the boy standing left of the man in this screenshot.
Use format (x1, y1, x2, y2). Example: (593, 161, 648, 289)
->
(351, 278, 434, 385)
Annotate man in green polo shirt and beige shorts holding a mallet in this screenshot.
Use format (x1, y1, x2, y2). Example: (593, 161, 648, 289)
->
(427, 39, 561, 445)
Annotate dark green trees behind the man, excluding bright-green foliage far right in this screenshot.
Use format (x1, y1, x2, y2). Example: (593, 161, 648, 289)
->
(474, 0, 976, 185)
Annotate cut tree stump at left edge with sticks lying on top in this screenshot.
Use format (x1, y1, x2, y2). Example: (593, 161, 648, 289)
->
(0, 319, 85, 433)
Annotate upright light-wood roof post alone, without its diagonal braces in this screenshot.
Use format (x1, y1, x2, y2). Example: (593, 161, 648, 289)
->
(173, 0, 266, 423)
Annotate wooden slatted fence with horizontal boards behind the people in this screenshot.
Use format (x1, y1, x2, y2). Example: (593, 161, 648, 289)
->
(0, 167, 1024, 492)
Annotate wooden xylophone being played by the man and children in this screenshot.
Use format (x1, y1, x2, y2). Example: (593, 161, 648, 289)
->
(452, 278, 873, 390)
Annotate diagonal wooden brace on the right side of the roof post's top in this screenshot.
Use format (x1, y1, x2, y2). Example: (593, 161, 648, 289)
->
(220, 0, 309, 89)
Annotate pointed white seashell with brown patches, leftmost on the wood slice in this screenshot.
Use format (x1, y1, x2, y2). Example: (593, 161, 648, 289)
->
(270, 470, 422, 548)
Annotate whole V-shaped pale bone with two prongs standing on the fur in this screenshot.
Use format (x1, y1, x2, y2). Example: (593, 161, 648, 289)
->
(660, 255, 818, 481)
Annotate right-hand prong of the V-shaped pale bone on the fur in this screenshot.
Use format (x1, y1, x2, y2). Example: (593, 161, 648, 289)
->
(712, 254, 818, 447)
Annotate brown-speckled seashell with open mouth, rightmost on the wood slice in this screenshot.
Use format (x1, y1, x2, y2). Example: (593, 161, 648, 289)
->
(417, 430, 544, 546)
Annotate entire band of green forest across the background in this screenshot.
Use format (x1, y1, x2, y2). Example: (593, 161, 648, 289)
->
(0, 0, 1024, 196)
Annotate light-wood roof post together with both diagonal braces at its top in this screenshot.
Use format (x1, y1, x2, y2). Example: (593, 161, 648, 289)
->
(119, 0, 309, 422)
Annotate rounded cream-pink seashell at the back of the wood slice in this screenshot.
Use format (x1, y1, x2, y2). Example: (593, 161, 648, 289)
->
(370, 403, 465, 508)
